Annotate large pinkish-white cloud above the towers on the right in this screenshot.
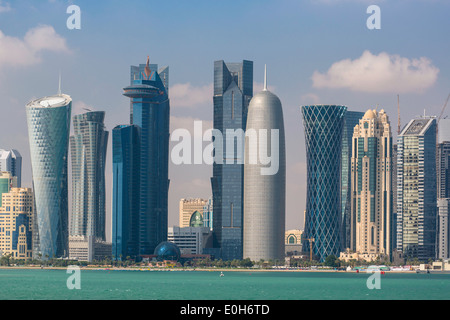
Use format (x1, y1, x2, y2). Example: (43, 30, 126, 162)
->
(312, 51, 439, 93)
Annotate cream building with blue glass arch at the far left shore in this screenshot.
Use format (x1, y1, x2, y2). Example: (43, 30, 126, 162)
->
(0, 188, 34, 260)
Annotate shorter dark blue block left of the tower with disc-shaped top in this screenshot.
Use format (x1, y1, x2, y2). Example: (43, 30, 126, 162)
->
(111, 125, 141, 260)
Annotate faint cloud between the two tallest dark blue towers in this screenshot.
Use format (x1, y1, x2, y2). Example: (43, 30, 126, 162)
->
(169, 83, 213, 108)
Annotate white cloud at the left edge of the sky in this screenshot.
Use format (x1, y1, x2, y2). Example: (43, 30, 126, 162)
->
(0, 25, 70, 68)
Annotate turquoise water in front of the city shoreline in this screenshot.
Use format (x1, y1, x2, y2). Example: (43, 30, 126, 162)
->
(0, 269, 450, 300)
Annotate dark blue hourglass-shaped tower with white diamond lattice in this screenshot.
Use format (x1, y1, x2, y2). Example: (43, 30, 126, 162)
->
(301, 105, 347, 262)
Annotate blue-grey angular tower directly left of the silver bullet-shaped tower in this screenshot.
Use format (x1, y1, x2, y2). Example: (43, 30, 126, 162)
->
(211, 60, 253, 260)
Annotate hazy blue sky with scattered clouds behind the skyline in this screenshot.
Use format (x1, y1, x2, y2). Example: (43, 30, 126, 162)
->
(0, 0, 450, 240)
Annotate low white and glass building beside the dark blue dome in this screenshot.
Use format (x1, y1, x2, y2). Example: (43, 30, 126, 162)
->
(167, 227, 213, 255)
